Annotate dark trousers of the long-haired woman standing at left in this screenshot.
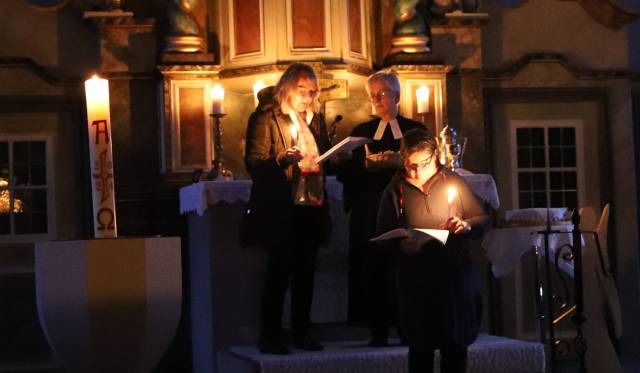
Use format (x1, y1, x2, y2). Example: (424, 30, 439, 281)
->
(261, 240, 318, 341)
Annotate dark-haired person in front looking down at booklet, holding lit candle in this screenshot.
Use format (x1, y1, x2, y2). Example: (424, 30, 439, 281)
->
(377, 130, 489, 373)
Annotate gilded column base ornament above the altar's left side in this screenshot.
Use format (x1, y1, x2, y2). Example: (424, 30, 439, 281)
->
(164, 0, 204, 53)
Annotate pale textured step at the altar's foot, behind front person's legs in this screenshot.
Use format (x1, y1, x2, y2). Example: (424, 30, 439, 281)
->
(218, 334, 545, 373)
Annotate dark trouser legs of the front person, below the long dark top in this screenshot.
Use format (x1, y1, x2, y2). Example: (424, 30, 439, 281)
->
(409, 345, 467, 373)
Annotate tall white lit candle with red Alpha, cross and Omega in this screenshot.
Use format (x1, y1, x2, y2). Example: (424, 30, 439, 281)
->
(84, 75, 118, 238)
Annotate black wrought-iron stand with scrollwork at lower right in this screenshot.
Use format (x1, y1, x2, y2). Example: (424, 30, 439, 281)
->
(536, 210, 592, 373)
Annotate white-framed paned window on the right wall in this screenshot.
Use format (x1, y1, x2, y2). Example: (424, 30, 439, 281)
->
(511, 120, 584, 209)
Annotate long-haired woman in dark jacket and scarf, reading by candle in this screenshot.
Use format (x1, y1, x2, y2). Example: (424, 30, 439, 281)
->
(245, 63, 331, 354)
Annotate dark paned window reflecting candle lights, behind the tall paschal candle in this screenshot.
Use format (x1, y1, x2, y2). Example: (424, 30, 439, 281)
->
(0, 139, 51, 237)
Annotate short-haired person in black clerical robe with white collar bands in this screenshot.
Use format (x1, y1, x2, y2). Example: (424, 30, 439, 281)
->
(338, 70, 424, 347)
